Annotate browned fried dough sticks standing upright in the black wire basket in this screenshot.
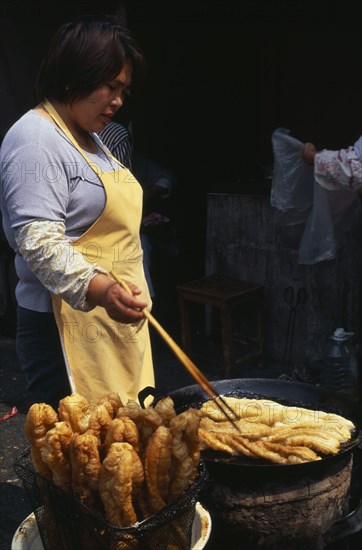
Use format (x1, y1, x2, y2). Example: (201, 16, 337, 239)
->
(25, 393, 200, 548)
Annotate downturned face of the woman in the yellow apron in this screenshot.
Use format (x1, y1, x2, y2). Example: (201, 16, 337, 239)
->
(67, 63, 132, 132)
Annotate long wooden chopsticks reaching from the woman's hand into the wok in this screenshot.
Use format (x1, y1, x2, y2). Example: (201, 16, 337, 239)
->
(110, 271, 241, 433)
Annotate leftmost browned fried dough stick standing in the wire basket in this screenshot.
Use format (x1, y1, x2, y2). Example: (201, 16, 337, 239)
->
(25, 403, 59, 479)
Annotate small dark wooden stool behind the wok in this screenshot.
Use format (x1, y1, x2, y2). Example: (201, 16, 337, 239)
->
(177, 276, 264, 378)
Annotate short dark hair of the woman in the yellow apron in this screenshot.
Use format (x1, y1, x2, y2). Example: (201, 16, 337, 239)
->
(35, 16, 145, 103)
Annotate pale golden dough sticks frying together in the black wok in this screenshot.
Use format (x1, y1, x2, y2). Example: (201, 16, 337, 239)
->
(199, 396, 355, 464)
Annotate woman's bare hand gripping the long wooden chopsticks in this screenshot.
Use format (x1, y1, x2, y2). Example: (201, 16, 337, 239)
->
(87, 273, 147, 323)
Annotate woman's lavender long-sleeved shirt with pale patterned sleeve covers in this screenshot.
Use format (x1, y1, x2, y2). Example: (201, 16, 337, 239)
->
(0, 110, 121, 311)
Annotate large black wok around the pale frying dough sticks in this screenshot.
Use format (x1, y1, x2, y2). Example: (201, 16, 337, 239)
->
(144, 378, 362, 542)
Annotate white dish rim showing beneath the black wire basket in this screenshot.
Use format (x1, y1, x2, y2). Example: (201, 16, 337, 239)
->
(11, 502, 211, 550)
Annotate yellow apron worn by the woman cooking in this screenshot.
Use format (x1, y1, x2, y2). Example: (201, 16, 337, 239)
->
(44, 102, 154, 403)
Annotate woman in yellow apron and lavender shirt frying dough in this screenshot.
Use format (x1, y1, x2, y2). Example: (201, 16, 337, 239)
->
(1, 18, 154, 406)
